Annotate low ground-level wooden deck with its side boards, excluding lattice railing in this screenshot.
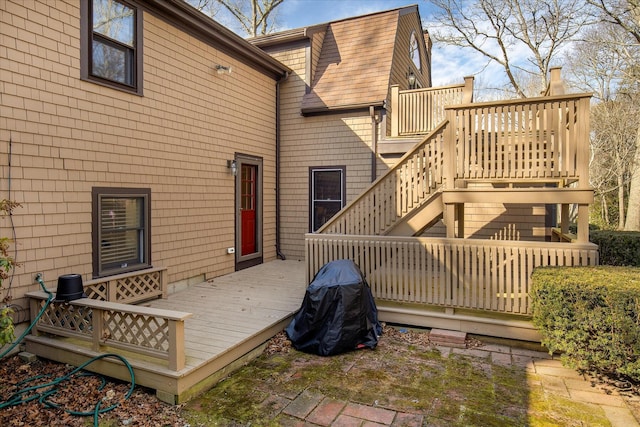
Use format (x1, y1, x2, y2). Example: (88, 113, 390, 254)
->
(25, 260, 307, 403)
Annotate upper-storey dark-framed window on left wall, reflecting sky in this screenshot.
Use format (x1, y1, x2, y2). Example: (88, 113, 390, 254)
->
(82, 0, 142, 94)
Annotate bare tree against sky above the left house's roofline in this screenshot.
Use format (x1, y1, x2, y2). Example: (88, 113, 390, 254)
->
(186, 0, 285, 37)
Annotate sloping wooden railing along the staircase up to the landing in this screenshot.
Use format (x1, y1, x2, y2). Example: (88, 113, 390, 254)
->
(318, 122, 446, 235)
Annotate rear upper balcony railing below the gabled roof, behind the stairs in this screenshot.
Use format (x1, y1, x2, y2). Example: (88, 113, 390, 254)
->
(391, 77, 473, 137)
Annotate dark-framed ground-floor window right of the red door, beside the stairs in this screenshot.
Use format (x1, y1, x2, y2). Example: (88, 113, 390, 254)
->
(309, 167, 345, 232)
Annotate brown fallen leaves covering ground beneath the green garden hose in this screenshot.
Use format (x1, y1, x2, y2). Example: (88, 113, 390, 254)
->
(0, 356, 187, 427)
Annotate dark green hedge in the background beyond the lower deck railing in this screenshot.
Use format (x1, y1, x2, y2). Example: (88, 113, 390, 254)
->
(589, 231, 640, 267)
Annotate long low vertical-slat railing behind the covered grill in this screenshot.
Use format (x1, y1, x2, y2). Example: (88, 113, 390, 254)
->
(305, 234, 598, 315)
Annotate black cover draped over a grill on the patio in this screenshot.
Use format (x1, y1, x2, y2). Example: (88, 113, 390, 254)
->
(285, 260, 382, 356)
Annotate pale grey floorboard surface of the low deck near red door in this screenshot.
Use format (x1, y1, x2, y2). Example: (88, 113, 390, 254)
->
(145, 260, 306, 367)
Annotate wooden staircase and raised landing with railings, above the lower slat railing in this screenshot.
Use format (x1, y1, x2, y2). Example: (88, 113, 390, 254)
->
(318, 94, 593, 242)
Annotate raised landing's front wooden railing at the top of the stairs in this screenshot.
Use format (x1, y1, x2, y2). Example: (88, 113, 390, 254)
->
(445, 94, 590, 187)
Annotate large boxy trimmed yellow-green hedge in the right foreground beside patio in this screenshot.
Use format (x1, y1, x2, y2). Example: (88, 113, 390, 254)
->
(531, 266, 640, 381)
